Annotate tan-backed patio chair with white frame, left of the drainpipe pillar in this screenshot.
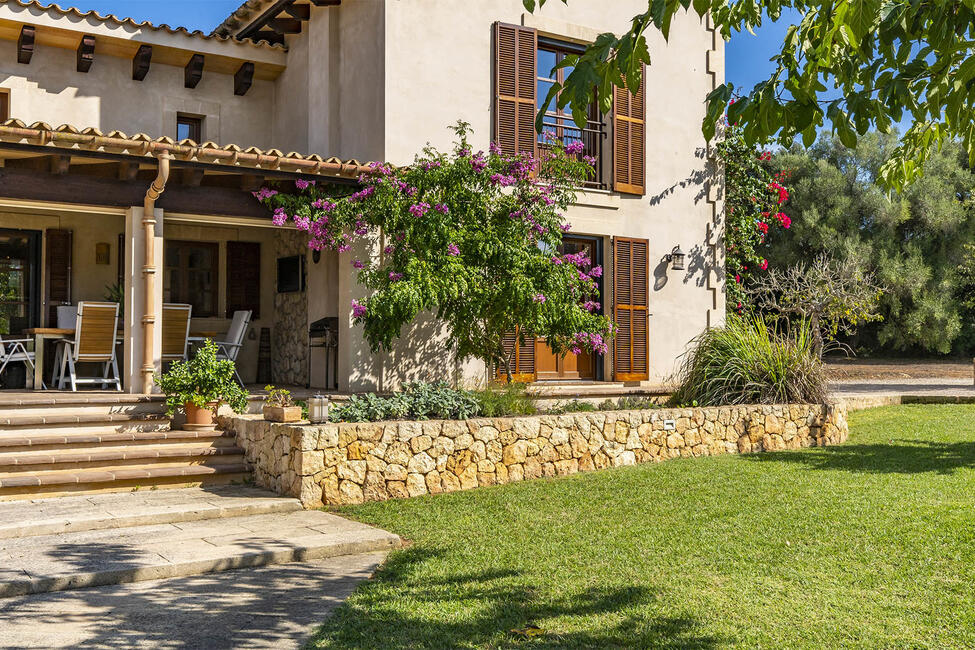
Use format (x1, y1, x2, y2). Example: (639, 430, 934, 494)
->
(58, 302, 122, 391)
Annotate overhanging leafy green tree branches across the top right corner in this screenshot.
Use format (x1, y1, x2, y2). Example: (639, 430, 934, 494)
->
(524, 0, 975, 188)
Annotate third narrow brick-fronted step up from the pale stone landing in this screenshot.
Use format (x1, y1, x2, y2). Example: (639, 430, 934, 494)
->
(0, 427, 233, 452)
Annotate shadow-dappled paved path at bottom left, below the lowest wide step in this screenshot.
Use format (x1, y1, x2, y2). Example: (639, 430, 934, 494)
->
(0, 553, 385, 649)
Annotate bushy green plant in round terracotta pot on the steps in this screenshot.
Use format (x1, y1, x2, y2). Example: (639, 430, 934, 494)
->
(155, 339, 247, 430)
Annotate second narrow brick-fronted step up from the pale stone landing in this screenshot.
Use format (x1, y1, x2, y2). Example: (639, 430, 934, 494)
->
(0, 438, 244, 479)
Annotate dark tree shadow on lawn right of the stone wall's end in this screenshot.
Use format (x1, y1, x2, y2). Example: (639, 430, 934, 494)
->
(744, 440, 975, 474)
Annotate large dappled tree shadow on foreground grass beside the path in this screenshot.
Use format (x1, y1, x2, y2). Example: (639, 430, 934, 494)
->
(309, 547, 730, 650)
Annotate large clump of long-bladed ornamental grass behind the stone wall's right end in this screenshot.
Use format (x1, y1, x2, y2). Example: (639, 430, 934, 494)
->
(671, 315, 829, 406)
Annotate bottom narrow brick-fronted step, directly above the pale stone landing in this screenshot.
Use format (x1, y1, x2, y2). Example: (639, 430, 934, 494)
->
(0, 464, 249, 499)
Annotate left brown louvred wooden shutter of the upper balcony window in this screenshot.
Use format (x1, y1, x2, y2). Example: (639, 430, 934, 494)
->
(494, 23, 538, 155)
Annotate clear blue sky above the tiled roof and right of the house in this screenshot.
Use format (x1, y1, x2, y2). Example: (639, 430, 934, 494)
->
(61, 0, 787, 91)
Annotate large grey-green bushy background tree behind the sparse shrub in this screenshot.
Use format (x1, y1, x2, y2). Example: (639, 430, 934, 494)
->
(769, 133, 975, 353)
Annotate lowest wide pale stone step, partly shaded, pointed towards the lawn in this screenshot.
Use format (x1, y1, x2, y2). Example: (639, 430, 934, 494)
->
(0, 510, 401, 597)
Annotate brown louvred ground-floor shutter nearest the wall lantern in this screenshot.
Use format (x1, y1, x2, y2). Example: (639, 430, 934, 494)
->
(613, 237, 650, 381)
